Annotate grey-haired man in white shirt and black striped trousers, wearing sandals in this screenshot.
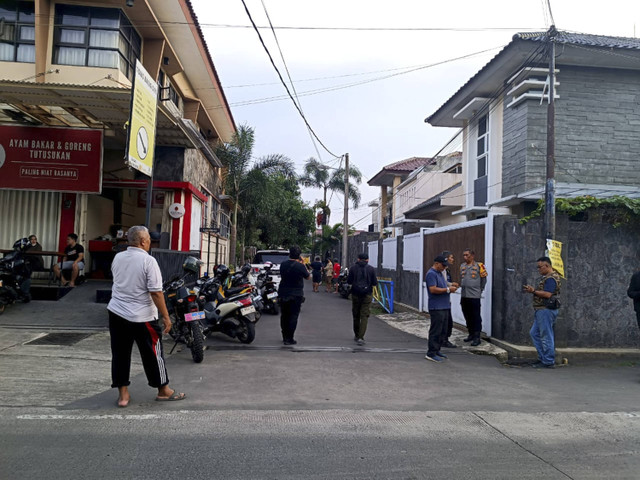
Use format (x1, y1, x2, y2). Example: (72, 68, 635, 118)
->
(107, 226, 185, 407)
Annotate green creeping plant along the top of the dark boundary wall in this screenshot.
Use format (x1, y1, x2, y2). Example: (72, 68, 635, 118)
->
(520, 195, 640, 227)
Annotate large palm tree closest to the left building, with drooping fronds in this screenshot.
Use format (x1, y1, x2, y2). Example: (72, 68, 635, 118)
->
(216, 125, 295, 262)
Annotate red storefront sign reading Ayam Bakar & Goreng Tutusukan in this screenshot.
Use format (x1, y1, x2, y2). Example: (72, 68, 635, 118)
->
(0, 125, 102, 193)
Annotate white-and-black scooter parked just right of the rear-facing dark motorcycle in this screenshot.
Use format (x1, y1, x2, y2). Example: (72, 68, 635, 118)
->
(198, 265, 258, 343)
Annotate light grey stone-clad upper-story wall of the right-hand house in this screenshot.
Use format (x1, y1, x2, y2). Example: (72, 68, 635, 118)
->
(502, 64, 640, 196)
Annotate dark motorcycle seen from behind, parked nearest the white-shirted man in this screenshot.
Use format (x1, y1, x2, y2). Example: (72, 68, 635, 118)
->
(163, 257, 205, 363)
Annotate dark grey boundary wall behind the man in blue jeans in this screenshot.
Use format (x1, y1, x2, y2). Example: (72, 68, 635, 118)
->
(492, 216, 640, 348)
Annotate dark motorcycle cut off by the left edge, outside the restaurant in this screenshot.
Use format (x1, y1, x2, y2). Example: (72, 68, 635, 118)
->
(0, 238, 31, 315)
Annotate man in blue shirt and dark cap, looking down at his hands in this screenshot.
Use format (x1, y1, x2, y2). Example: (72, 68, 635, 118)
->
(424, 255, 457, 363)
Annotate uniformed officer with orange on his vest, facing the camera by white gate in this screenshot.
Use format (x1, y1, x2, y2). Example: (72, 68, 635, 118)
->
(460, 248, 487, 347)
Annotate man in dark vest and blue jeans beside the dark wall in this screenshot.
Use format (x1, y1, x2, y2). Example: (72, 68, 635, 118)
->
(522, 257, 560, 368)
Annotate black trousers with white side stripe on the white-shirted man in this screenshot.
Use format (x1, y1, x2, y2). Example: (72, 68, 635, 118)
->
(109, 311, 169, 388)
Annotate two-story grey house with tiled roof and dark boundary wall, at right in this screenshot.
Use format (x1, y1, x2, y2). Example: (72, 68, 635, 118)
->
(424, 32, 640, 347)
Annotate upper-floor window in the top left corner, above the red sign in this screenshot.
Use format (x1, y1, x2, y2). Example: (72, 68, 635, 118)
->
(0, 1, 36, 63)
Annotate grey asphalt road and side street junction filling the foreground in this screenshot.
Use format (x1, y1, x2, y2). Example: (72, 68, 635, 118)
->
(0, 280, 640, 479)
